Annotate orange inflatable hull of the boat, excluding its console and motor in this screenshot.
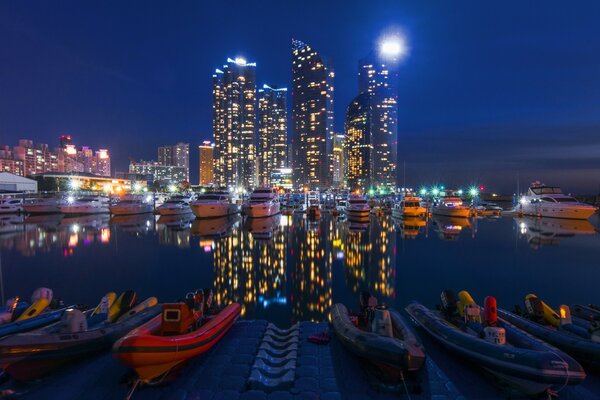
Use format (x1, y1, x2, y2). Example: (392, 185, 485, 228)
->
(113, 303, 241, 382)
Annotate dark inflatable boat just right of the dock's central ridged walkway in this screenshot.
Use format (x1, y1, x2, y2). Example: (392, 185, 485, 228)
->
(330, 292, 425, 379)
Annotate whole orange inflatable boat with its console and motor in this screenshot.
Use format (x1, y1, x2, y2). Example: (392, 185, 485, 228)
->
(113, 292, 241, 383)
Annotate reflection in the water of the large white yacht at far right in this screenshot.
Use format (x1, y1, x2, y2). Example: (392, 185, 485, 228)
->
(514, 218, 596, 249)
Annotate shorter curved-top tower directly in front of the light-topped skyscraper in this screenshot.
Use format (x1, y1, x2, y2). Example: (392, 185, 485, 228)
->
(345, 92, 373, 190)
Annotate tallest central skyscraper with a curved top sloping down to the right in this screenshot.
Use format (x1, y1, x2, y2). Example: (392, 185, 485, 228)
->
(292, 39, 334, 189)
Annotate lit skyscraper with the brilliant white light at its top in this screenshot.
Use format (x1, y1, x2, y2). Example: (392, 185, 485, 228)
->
(358, 52, 398, 188)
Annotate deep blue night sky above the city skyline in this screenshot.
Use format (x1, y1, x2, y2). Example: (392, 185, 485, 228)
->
(0, 0, 600, 193)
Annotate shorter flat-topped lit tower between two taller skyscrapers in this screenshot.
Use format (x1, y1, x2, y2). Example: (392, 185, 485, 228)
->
(257, 85, 288, 185)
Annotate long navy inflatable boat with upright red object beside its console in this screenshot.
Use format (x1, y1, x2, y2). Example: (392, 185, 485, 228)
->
(406, 290, 586, 395)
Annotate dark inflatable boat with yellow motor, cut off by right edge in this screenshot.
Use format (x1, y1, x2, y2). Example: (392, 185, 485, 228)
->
(498, 294, 600, 370)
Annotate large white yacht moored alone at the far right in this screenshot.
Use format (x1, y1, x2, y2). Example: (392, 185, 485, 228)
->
(516, 182, 596, 219)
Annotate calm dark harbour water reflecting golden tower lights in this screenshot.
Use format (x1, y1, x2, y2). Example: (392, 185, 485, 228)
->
(0, 214, 600, 326)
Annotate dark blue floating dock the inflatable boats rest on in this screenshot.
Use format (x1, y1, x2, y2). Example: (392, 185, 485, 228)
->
(8, 320, 600, 400)
